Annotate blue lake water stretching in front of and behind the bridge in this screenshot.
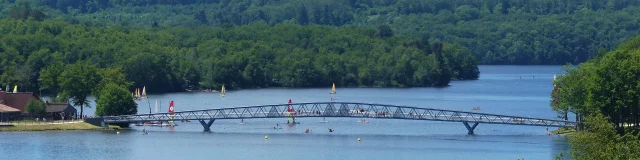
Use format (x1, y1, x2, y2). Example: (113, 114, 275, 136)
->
(0, 66, 570, 160)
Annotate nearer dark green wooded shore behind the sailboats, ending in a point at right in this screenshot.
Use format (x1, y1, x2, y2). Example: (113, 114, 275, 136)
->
(0, 19, 479, 92)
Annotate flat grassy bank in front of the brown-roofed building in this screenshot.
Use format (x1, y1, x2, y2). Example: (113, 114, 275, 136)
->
(0, 122, 120, 131)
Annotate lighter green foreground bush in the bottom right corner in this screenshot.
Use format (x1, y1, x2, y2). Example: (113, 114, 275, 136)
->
(569, 114, 640, 160)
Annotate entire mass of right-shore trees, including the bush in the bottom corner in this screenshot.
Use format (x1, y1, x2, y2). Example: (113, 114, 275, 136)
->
(551, 36, 640, 159)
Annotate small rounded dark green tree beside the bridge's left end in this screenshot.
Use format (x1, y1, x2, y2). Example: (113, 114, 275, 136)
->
(96, 83, 138, 116)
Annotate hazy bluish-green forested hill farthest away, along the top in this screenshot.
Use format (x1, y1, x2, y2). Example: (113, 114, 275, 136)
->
(0, 0, 640, 64)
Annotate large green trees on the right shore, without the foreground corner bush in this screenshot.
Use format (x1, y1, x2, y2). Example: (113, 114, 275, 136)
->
(554, 34, 640, 128)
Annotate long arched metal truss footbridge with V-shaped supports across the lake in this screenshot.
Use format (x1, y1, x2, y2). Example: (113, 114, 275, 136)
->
(103, 102, 576, 134)
